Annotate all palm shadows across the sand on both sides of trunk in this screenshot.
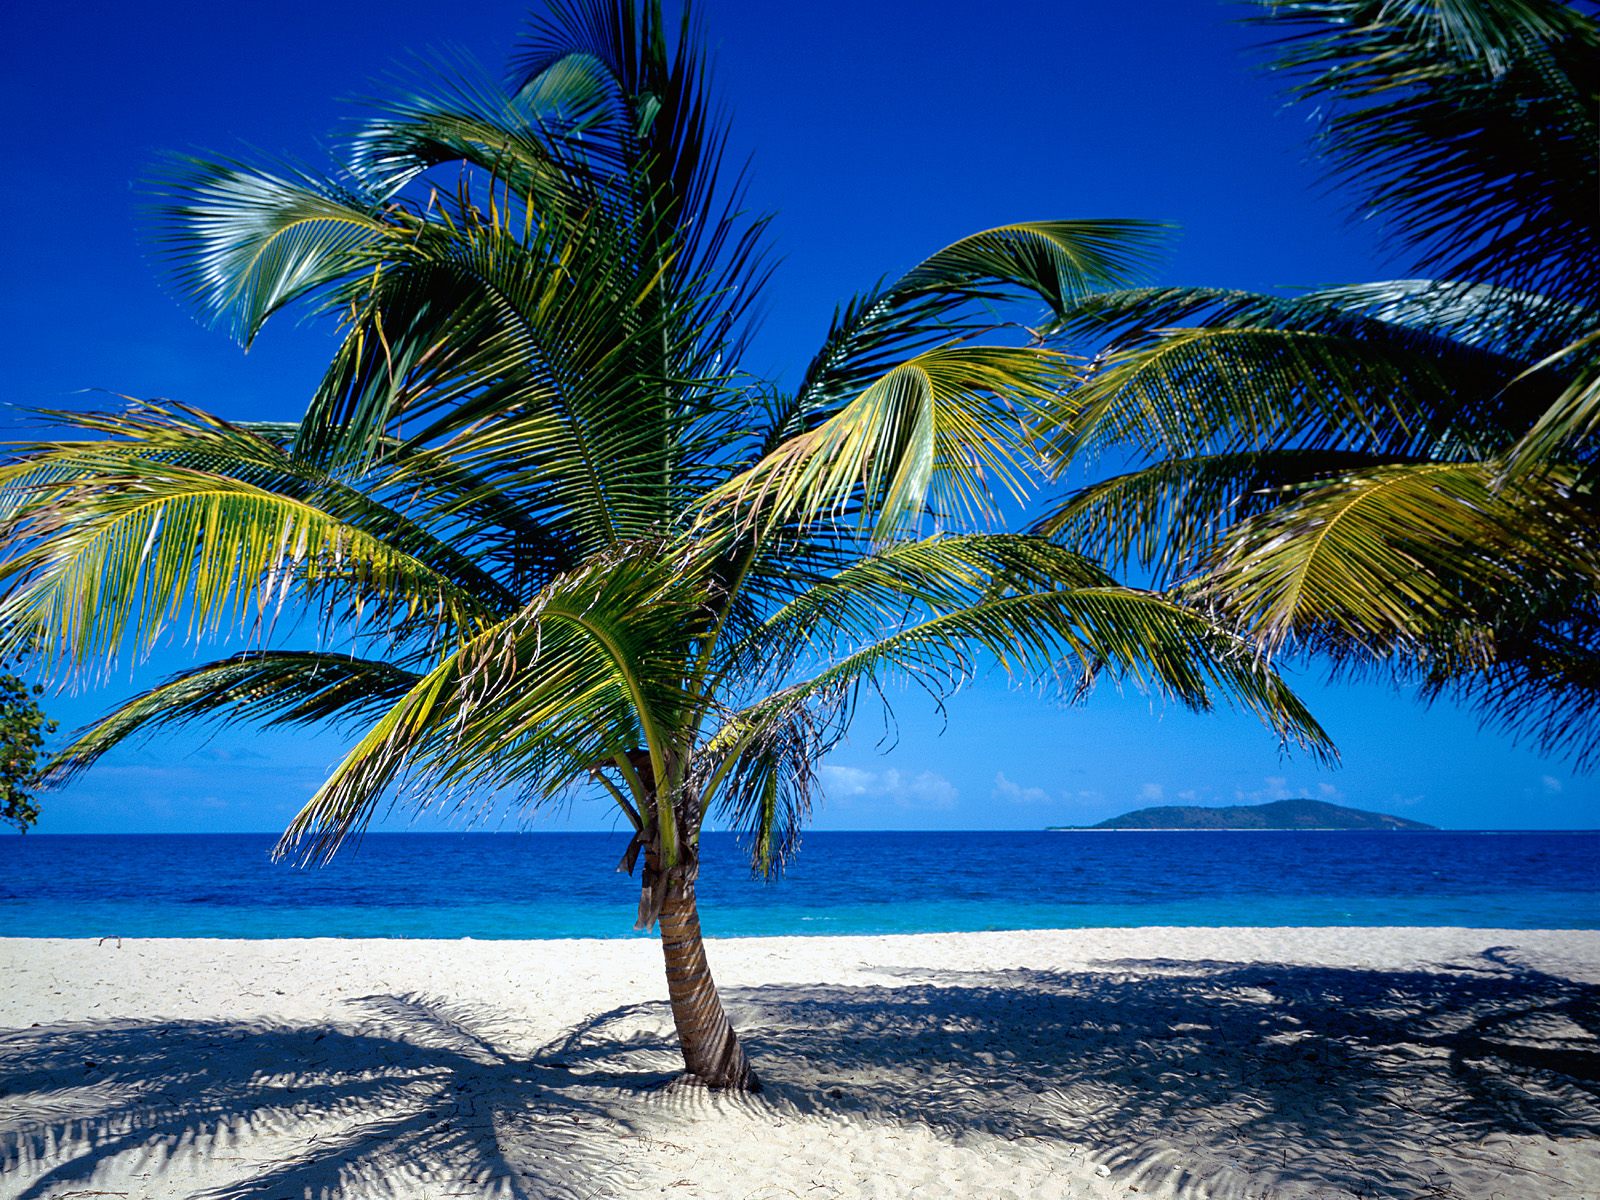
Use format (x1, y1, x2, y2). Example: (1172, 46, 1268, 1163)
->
(0, 952, 1600, 1200)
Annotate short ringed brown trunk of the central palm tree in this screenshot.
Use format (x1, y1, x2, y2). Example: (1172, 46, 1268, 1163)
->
(661, 878, 762, 1091)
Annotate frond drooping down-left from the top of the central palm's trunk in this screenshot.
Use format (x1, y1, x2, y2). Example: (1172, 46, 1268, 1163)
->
(280, 544, 704, 866)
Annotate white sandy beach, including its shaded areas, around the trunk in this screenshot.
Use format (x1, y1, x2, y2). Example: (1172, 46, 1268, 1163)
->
(0, 928, 1600, 1200)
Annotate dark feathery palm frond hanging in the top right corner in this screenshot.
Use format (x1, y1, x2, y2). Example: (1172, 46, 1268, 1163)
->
(1259, 0, 1600, 315)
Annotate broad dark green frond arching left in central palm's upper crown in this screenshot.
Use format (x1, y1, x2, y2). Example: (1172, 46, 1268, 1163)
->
(296, 195, 717, 549)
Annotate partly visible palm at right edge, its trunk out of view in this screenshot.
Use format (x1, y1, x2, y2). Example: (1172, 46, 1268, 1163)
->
(1038, 0, 1600, 768)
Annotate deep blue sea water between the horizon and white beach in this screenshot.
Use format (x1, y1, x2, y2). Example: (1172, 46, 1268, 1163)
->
(0, 830, 1600, 938)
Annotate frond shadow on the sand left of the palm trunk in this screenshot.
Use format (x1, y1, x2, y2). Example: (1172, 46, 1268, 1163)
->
(0, 995, 659, 1200)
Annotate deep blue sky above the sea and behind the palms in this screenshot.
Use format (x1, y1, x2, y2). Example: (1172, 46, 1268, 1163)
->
(0, 0, 1600, 832)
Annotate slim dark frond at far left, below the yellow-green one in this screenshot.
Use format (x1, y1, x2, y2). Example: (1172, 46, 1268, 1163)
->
(45, 650, 418, 784)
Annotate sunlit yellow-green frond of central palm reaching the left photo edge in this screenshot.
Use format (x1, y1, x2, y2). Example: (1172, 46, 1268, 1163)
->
(0, 422, 493, 678)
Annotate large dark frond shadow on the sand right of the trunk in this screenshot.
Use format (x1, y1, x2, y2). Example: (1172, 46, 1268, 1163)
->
(560, 952, 1600, 1200)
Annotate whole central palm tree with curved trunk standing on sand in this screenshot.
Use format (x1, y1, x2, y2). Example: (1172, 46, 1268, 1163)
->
(0, 0, 1328, 1088)
